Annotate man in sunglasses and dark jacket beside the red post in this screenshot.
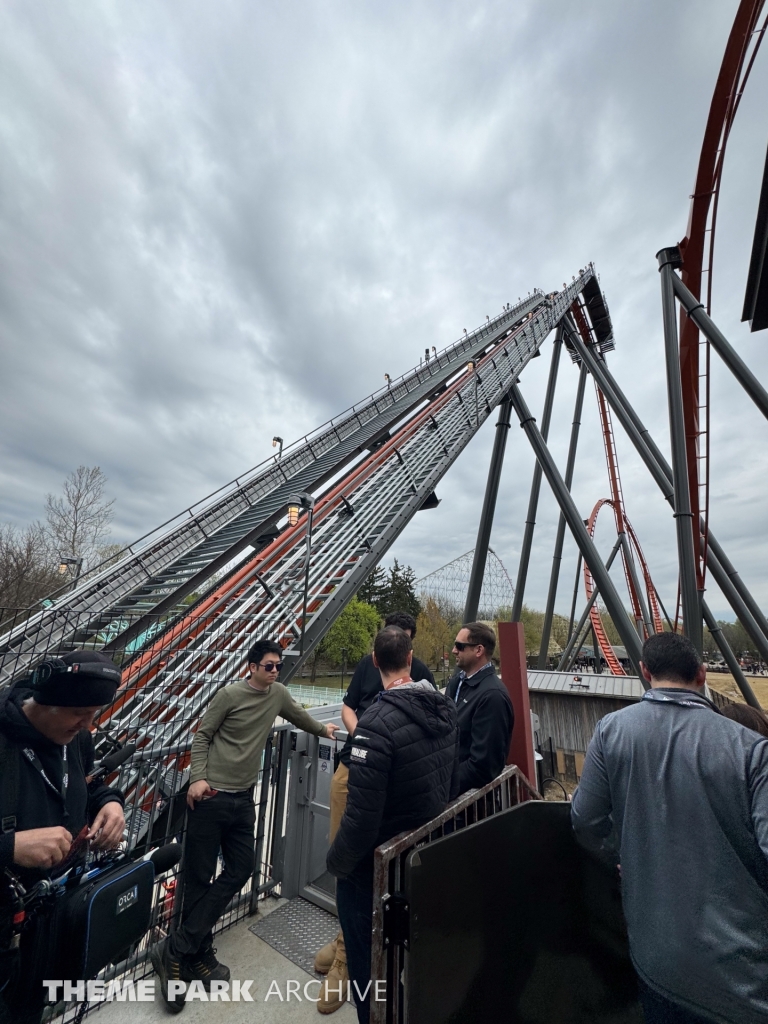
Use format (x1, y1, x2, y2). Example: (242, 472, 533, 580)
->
(445, 623, 515, 793)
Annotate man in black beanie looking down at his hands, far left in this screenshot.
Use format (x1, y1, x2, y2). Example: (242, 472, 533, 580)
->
(0, 650, 125, 1024)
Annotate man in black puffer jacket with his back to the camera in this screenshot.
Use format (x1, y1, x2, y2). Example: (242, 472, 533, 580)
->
(327, 627, 459, 1024)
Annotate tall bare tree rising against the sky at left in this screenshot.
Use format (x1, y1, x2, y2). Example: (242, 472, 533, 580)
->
(45, 466, 115, 570)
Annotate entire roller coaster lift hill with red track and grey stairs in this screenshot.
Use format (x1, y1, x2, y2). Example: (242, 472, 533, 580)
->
(0, 266, 610, 845)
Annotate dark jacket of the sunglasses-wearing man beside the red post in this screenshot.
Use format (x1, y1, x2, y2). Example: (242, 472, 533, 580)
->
(445, 665, 515, 793)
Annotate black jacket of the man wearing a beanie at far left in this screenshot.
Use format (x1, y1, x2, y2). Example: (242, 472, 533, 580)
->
(0, 686, 123, 881)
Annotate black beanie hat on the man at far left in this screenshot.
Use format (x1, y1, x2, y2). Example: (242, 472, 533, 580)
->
(30, 650, 122, 708)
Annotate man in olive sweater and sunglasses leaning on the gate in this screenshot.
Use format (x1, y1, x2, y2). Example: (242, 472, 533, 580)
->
(152, 640, 338, 1013)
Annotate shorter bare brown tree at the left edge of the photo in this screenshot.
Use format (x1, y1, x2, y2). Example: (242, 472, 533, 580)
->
(0, 522, 60, 620)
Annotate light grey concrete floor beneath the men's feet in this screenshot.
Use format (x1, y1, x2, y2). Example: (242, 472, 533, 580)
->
(88, 897, 357, 1024)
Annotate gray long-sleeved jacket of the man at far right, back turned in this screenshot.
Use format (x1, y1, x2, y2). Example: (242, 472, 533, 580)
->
(571, 688, 768, 1024)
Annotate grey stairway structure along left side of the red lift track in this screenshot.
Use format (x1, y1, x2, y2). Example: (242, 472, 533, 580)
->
(0, 292, 552, 684)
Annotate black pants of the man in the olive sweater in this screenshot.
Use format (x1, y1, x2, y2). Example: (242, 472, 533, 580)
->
(171, 790, 256, 956)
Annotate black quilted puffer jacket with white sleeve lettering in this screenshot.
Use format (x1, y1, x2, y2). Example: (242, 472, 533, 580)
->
(327, 682, 458, 878)
